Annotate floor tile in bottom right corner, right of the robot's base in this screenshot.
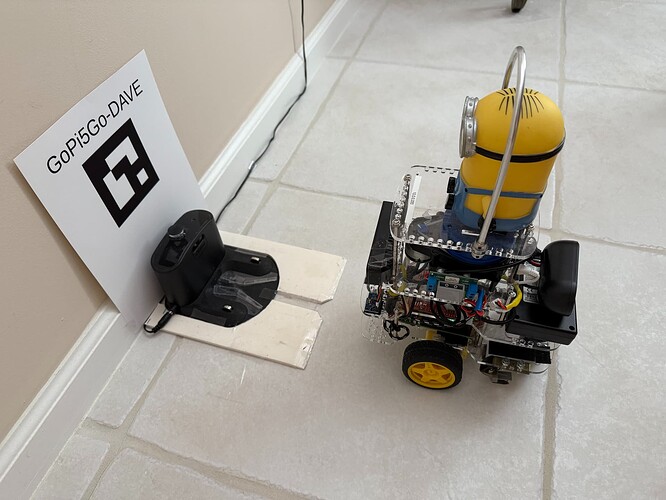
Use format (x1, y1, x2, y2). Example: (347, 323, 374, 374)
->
(554, 242, 666, 498)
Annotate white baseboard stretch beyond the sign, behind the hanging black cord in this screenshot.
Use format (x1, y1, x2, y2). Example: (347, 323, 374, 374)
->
(199, 0, 360, 215)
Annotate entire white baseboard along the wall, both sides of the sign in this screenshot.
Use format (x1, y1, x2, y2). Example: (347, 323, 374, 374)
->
(0, 0, 359, 500)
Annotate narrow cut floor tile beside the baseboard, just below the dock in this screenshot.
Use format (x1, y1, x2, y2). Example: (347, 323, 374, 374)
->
(88, 333, 175, 427)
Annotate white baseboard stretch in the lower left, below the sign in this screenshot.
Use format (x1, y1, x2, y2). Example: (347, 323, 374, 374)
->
(0, 301, 138, 499)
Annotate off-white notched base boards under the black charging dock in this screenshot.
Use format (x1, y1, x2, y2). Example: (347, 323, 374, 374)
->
(146, 232, 345, 369)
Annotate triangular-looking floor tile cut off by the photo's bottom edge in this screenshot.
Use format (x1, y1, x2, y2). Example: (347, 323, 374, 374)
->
(92, 449, 260, 500)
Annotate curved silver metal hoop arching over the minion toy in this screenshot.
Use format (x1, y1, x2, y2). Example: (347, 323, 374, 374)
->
(473, 45, 527, 259)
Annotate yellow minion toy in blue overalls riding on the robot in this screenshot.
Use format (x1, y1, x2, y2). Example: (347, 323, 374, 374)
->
(452, 83, 565, 232)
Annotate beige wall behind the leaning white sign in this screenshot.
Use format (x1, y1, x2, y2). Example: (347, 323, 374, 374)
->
(0, 0, 333, 440)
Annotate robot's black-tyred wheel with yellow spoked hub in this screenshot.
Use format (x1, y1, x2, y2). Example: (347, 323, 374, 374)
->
(402, 340, 462, 389)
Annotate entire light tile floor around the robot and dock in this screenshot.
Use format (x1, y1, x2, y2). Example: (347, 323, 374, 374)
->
(35, 0, 666, 499)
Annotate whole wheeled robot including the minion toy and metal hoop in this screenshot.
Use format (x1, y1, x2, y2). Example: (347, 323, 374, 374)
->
(361, 47, 579, 389)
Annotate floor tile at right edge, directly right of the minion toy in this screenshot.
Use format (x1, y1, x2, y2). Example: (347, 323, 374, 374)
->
(557, 84, 666, 247)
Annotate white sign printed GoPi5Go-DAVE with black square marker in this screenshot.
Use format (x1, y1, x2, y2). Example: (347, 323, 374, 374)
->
(14, 51, 205, 326)
